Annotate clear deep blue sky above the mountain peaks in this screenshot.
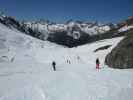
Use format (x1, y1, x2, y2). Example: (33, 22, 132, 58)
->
(0, 0, 133, 22)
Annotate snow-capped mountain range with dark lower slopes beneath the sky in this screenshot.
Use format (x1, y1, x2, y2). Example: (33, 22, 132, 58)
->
(0, 15, 133, 47)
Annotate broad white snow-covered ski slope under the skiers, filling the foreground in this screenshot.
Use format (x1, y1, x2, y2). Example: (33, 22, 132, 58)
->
(0, 24, 133, 100)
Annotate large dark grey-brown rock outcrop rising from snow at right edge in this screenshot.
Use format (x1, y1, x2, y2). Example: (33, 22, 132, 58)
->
(105, 30, 133, 69)
